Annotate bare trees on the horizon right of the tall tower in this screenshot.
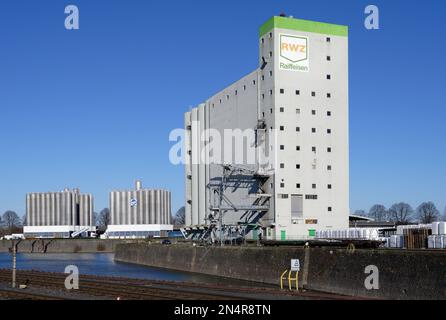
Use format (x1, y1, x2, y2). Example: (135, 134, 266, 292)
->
(355, 201, 446, 224)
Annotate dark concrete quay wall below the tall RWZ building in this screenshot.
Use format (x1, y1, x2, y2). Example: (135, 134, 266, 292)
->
(115, 243, 446, 299)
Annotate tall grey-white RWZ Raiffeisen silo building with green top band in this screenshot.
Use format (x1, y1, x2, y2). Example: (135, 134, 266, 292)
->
(185, 16, 349, 242)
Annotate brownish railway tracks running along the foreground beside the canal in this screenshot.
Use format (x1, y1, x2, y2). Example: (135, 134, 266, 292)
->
(0, 269, 361, 300)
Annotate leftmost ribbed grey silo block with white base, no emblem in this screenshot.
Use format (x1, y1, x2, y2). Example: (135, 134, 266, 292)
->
(23, 189, 96, 238)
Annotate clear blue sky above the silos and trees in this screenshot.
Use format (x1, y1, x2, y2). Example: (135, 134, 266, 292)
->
(0, 0, 446, 215)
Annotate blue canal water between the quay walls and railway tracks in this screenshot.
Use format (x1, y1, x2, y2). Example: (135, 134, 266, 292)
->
(0, 253, 246, 285)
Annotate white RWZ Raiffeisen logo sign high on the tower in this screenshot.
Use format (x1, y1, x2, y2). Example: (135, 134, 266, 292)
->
(279, 34, 309, 72)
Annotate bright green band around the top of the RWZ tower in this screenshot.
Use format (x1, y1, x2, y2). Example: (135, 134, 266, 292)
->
(259, 17, 348, 37)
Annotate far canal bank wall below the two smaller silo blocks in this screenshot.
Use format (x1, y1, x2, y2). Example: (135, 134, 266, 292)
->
(0, 239, 134, 253)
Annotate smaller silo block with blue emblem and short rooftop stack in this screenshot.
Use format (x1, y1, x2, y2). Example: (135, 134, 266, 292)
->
(103, 181, 173, 239)
